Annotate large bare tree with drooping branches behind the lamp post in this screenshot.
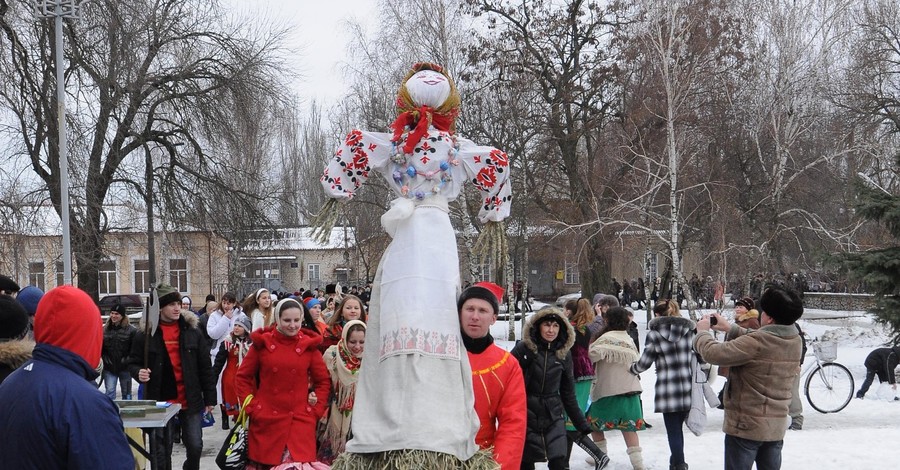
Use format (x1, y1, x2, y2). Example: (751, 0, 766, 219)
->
(0, 0, 284, 296)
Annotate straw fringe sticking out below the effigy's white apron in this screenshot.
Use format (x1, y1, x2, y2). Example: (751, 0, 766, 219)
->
(331, 449, 500, 470)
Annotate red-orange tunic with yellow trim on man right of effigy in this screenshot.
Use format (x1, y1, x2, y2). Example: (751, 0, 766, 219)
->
(468, 344, 528, 470)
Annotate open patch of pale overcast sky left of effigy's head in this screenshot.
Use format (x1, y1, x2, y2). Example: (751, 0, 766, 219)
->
(227, 0, 377, 105)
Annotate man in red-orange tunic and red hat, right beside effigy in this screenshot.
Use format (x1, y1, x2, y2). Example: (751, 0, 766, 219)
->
(456, 282, 528, 470)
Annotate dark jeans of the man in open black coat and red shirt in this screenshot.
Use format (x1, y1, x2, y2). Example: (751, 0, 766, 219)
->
(150, 410, 203, 470)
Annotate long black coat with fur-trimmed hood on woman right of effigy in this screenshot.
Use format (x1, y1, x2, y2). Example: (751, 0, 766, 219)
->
(511, 308, 590, 462)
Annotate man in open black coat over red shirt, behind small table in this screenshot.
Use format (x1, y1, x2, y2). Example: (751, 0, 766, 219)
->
(128, 284, 216, 470)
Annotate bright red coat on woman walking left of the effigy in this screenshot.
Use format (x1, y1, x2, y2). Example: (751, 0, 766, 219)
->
(235, 327, 331, 465)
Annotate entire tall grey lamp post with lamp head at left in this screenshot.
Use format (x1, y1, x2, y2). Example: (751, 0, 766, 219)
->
(37, 0, 83, 284)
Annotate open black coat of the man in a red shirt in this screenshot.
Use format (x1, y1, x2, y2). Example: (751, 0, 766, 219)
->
(128, 312, 216, 412)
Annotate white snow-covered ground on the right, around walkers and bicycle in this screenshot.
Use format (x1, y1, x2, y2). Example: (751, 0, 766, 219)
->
(491, 304, 900, 470)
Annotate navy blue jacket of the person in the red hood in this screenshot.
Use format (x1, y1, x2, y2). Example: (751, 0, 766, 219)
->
(0, 343, 134, 470)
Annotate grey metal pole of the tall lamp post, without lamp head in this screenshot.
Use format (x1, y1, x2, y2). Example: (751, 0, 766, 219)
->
(56, 7, 72, 284)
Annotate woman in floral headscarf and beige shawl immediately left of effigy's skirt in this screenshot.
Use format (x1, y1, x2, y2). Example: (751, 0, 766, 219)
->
(318, 320, 366, 465)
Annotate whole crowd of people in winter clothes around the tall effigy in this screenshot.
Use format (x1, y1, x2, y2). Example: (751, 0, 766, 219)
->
(0, 270, 898, 470)
